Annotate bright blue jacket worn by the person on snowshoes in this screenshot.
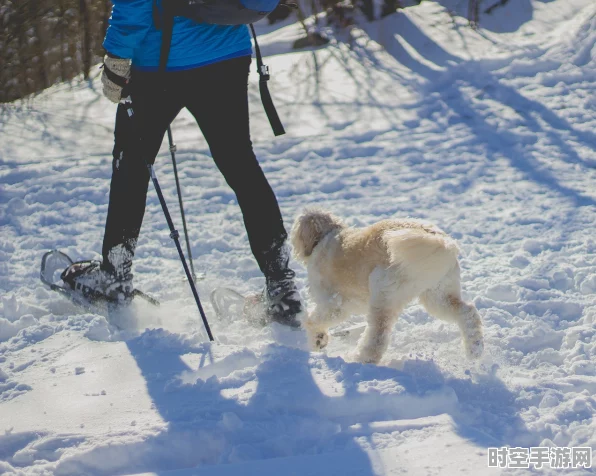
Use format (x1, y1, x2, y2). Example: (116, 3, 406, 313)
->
(103, 0, 252, 71)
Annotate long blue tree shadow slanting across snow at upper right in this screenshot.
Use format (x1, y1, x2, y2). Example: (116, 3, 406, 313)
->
(336, 7, 596, 206)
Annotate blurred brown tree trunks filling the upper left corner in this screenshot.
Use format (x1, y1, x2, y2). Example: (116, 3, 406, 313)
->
(0, 0, 112, 102)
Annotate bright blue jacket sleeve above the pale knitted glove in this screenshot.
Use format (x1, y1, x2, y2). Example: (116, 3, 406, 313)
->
(103, 0, 153, 58)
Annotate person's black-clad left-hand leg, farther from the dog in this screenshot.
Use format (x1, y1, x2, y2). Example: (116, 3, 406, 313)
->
(102, 72, 182, 275)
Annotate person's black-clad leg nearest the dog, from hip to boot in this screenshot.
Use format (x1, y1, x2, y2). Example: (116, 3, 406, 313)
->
(185, 56, 301, 320)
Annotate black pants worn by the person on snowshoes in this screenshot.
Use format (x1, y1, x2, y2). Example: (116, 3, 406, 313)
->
(102, 56, 287, 277)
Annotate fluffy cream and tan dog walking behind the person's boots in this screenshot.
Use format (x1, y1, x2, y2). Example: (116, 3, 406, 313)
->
(291, 209, 484, 363)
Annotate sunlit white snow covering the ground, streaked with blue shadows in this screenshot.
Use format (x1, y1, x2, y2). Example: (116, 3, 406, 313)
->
(0, 0, 596, 476)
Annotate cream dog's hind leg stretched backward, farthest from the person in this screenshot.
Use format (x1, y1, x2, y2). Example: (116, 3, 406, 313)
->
(420, 267, 484, 359)
